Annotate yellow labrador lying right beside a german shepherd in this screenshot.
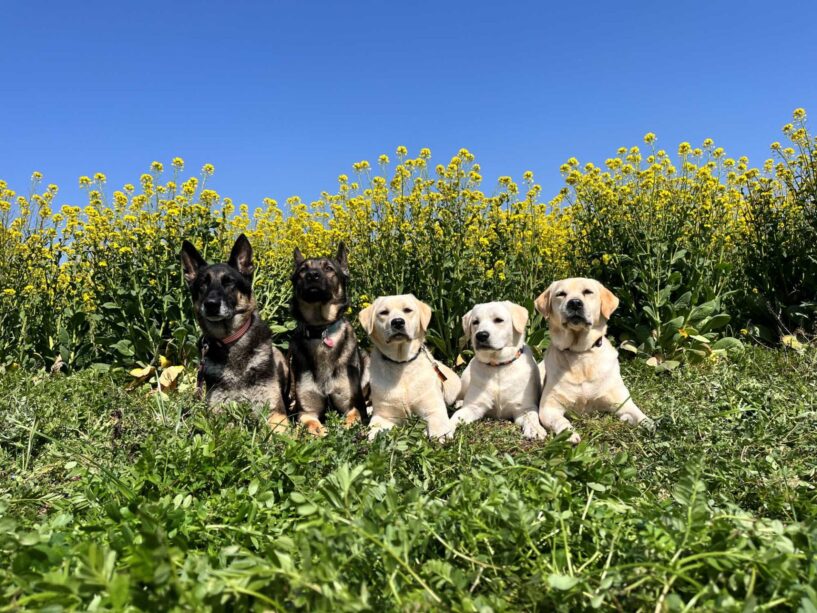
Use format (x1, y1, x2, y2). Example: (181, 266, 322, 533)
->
(359, 294, 460, 439)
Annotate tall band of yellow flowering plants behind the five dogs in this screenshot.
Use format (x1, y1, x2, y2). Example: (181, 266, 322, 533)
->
(0, 109, 817, 370)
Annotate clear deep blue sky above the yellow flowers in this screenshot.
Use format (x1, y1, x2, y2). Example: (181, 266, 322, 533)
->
(0, 0, 817, 207)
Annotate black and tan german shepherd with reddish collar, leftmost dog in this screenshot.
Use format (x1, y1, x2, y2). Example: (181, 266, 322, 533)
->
(181, 234, 288, 429)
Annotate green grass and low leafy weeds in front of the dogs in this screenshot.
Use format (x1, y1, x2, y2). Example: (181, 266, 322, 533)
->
(0, 349, 817, 611)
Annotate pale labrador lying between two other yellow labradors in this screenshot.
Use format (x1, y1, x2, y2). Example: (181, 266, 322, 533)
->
(451, 300, 547, 439)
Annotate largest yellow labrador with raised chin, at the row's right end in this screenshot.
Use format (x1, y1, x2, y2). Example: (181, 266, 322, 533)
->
(535, 278, 654, 445)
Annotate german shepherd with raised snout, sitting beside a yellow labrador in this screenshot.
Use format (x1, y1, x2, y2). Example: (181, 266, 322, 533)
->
(289, 243, 368, 435)
